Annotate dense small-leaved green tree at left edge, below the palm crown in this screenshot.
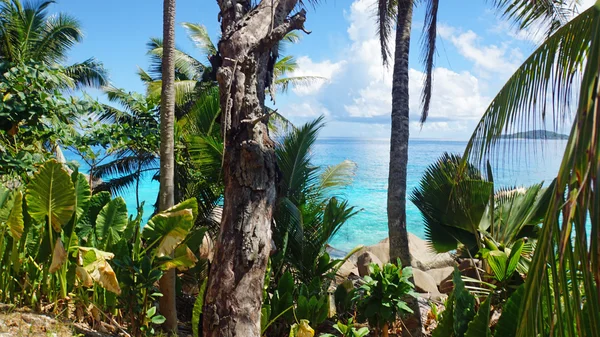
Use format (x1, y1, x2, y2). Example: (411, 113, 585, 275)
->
(0, 61, 97, 176)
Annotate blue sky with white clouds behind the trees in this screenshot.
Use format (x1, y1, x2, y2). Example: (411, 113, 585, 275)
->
(51, 0, 595, 140)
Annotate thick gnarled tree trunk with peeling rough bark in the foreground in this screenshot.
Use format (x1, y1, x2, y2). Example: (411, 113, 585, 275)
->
(203, 0, 306, 337)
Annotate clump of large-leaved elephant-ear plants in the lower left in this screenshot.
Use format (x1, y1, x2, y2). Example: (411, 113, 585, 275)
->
(0, 160, 205, 336)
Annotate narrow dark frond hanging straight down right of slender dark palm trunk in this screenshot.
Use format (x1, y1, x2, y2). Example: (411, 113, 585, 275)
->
(421, 0, 439, 123)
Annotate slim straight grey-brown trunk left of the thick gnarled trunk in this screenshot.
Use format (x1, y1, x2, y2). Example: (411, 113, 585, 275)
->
(158, 0, 177, 331)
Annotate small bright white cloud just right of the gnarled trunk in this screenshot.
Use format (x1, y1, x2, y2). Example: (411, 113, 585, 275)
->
(289, 56, 346, 96)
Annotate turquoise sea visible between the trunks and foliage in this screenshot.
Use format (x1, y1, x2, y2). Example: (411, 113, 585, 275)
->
(77, 138, 566, 251)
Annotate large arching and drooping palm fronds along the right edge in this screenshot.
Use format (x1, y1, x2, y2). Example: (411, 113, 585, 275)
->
(465, 1, 600, 337)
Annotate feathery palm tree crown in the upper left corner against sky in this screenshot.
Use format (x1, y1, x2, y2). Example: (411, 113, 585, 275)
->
(0, 0, 108, 88)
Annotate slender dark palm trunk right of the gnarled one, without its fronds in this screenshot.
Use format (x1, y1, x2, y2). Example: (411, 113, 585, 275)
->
(387, 0, 422, 337)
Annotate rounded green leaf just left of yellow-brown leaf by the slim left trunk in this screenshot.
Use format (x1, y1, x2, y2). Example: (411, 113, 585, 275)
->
(96, 197, 128, 249)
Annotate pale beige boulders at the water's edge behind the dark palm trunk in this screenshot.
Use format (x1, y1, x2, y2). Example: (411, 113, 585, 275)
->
(337, 233, 460, 301)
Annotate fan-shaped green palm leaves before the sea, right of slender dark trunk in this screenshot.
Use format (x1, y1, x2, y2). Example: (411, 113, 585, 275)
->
(411, 154, 549, 253)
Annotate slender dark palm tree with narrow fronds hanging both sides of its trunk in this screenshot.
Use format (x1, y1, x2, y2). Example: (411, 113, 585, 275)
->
(377, 0, 439, 330)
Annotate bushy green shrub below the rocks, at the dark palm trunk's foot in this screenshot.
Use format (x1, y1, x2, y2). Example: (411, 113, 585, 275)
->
(355, 262, 417, 336)
